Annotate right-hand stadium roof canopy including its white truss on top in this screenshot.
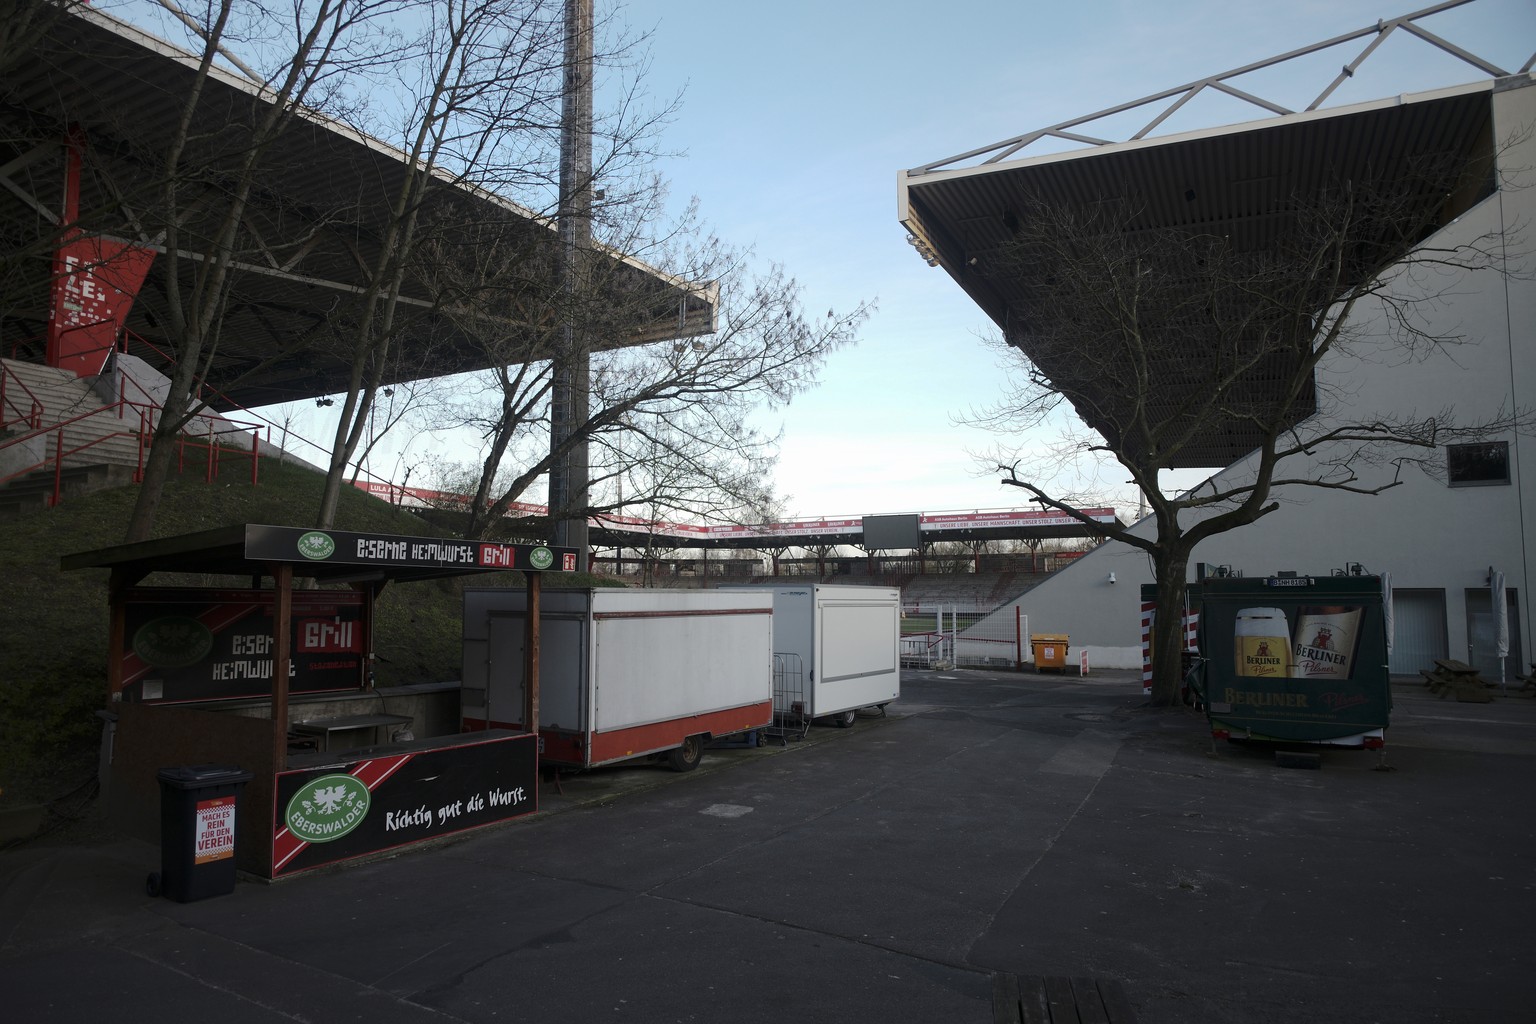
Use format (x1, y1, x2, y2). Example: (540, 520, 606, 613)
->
(899, 0, 1531, 468)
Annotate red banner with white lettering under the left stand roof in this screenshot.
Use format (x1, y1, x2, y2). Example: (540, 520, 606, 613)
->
(48, 236, 155, 376)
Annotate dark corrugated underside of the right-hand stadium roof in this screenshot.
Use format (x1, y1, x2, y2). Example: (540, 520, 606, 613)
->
(906, 83, 1491, 468)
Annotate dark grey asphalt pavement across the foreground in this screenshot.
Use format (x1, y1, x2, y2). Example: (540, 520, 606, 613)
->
(0, 669, 1536, 1024)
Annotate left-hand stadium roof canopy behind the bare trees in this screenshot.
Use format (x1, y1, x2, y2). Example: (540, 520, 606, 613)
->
(0, 6, 716, 410)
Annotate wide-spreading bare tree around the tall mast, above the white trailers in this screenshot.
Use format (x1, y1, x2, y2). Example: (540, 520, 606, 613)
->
(448, 216, 869, 536)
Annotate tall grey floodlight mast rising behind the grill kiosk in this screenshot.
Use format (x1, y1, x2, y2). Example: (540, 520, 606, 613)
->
(550, 0, 593, 573)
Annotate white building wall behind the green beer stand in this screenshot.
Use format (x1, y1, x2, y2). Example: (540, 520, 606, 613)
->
(997, 77, 1536, 672)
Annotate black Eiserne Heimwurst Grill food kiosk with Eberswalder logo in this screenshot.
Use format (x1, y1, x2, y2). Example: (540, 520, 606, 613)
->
(61, 524, 576, 878)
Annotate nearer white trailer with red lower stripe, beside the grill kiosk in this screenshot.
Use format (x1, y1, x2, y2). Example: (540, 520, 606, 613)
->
(461, 588, 773, 771)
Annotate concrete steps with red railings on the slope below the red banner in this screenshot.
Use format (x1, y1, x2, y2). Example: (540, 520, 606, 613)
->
(0, 359, 140, 517)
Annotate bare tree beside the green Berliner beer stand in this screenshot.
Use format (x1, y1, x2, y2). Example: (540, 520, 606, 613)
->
(972, 163, 1519, 703)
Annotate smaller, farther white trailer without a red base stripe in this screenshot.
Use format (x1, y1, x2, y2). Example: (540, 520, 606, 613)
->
(742, 583, 902, 728)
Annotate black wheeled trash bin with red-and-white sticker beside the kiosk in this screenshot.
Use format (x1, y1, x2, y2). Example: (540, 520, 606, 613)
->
(146, 765, 253, 903)
